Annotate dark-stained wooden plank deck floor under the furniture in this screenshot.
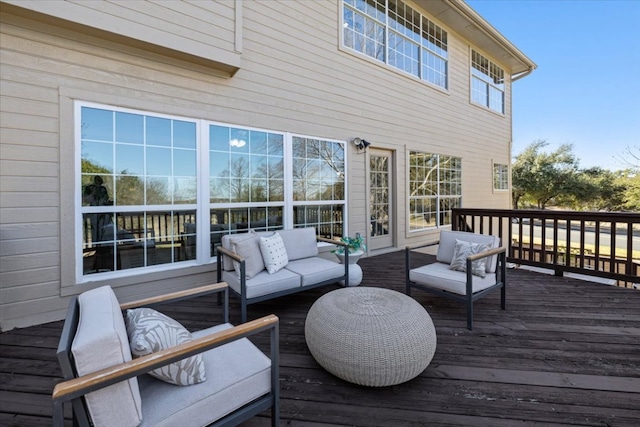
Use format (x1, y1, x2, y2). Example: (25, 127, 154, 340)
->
(0, 252, 640, 427)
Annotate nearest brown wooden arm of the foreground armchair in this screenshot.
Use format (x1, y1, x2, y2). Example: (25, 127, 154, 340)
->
(52, 314, 279, 403)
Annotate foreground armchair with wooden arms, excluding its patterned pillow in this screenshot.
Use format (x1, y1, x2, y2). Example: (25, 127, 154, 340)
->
(52, 283, 279, 427)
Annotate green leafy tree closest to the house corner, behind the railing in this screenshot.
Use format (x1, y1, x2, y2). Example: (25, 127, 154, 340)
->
(512, 140, 584, 209)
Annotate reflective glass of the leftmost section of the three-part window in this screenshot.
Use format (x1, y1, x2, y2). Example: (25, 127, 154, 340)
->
(80, 106, 197, 274)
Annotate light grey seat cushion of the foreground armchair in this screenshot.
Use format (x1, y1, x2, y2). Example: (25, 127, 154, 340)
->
(140, 326, 271, 427)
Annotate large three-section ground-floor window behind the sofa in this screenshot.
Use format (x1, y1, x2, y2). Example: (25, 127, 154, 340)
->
(76, 102, 346, 281)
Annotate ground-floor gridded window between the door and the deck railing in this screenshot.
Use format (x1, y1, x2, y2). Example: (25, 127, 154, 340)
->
(409, 151, 462, 231)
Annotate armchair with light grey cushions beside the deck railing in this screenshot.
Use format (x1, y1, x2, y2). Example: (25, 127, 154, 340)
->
(405, 231, 507, 330)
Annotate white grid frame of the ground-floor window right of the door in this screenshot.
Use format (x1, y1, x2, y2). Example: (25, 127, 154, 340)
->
(406, 150, 462, 234)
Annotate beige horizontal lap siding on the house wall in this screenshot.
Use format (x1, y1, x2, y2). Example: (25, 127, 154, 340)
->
(0, 0, 524, 330)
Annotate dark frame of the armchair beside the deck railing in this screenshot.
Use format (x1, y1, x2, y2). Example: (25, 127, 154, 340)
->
(405, 241, 507, 331)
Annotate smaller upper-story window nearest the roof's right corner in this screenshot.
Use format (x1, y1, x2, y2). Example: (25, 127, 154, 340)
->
(471, 50, 504, 114)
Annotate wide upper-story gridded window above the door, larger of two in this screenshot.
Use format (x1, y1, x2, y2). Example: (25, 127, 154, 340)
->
(342, 0, 448, 89)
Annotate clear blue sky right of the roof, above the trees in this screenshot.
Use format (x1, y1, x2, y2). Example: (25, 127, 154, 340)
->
(466, 0, 640, 170)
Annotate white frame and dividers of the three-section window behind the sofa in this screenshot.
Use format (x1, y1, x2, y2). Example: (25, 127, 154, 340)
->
(71, 99, 348, 284)
